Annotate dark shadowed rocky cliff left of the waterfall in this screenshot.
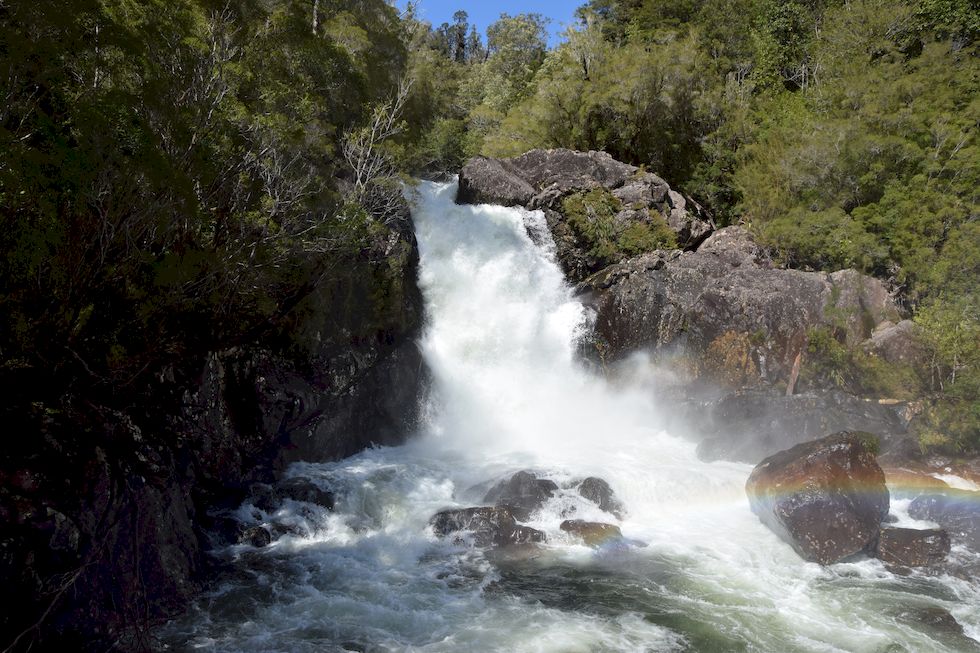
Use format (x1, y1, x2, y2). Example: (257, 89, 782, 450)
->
(0, 213, 424, 651)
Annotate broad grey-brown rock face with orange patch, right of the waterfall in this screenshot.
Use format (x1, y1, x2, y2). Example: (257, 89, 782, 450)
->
(578, 227, 899, 390)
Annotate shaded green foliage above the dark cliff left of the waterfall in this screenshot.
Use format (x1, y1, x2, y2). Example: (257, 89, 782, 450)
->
(0, 0, 418, 406)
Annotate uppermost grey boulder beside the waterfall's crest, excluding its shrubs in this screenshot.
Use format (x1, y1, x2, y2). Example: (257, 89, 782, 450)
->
(456, 149, 715, 281)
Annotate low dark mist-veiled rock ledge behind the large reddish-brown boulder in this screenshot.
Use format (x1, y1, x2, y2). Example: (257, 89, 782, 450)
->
(688, 389, 918, 465)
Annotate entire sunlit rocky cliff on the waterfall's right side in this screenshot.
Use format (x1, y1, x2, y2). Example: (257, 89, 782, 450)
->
(457, 150, 916, 463)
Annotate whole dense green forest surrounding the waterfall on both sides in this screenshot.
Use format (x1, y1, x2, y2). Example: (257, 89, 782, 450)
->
(0, 0, 980, 454)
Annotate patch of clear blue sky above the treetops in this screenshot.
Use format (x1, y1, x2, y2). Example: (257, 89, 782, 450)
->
(397, 0, 585, 45)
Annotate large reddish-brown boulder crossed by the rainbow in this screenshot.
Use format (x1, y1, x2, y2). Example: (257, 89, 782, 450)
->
(745, 431, 889, 565)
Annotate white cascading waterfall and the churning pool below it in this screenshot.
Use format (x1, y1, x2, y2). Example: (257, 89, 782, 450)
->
(161, 183, 980, 652)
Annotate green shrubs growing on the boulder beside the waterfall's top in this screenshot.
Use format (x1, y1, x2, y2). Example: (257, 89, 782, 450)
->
(562, 188, 677, 267)
